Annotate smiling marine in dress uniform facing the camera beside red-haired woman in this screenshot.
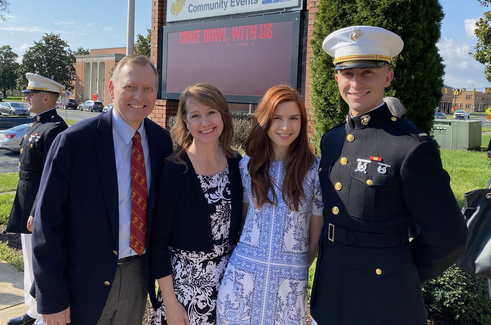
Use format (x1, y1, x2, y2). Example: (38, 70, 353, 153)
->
(311, 26, 467, 325)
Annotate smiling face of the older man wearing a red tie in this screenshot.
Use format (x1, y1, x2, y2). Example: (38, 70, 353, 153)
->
(109, 64, 157, 130)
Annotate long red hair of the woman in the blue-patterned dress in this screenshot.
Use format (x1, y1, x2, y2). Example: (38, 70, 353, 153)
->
(244, 85, 314, 211)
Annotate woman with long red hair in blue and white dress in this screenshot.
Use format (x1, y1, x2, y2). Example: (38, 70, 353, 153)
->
(217, 86, 323, 325)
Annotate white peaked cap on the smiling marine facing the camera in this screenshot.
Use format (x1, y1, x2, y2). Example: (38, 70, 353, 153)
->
(322, 26, 404, 70)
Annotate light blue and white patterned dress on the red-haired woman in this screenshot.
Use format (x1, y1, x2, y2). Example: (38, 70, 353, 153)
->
(217, 156, 323, 325)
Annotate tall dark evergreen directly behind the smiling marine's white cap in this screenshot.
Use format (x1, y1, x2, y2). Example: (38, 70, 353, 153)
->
(310, 0, 444, 147)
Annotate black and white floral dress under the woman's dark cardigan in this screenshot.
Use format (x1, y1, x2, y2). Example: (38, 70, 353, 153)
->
(151, 166, 233, 325)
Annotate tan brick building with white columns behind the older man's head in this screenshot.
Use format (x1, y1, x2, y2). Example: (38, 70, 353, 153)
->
(71, 47, 126, 105)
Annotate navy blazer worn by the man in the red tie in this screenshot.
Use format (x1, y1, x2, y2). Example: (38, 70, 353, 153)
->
(32, 111, 172, 325)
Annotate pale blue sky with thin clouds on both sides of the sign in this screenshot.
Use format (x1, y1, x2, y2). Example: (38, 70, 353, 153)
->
(0, 0, 491, 91)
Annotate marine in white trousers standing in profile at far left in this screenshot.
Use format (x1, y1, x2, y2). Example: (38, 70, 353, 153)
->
(6, 73, 68, 325)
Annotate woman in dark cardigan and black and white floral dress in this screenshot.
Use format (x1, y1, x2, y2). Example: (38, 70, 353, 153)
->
(148, 83, 242, 325)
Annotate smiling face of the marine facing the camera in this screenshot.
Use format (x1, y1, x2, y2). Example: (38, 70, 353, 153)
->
(335, 65, 394, 116)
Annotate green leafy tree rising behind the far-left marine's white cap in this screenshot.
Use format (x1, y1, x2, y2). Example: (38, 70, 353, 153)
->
(17, 33, 76, 90)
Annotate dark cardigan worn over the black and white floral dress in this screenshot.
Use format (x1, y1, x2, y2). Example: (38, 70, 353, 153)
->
(149, 154, 243, 284)
